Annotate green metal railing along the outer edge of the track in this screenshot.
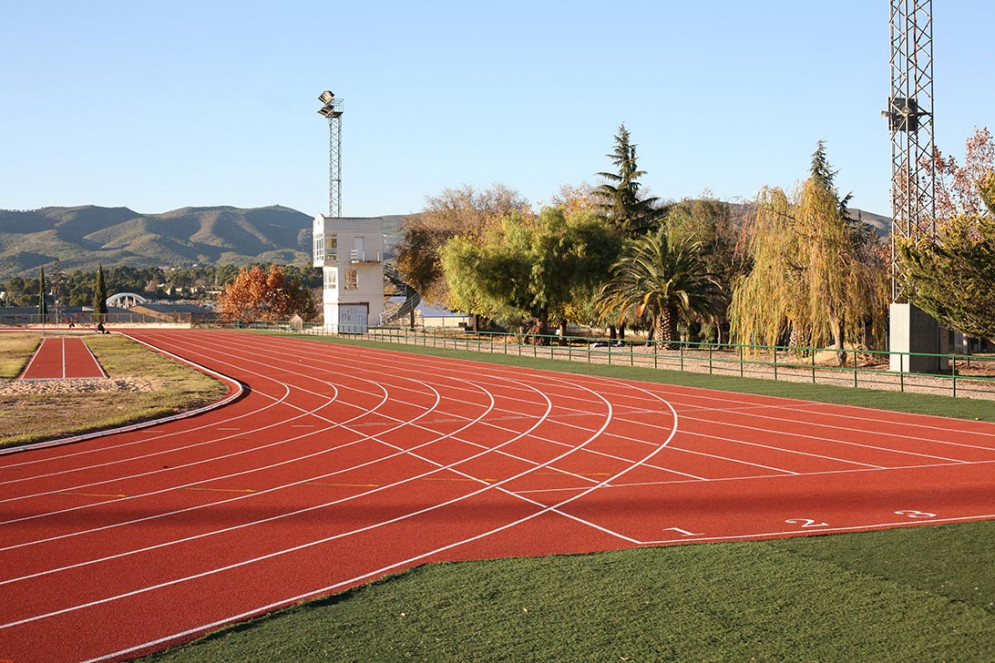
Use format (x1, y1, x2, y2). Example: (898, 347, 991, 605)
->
(272, 325, 995, 399)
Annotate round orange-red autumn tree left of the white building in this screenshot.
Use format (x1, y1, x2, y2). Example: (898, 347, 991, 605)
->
(218, 265, 317, 322)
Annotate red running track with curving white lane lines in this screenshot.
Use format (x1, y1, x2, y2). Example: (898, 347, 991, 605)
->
(0, 330, 995, 663)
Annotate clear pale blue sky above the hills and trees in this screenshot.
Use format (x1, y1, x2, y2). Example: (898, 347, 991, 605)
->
(0, 0, 995, 216)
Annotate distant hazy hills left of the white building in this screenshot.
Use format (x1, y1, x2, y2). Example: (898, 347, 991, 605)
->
(0, 205, 320, 278)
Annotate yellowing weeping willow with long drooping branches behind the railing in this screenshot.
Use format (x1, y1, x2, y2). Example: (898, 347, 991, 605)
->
(729, 143, 888, 356)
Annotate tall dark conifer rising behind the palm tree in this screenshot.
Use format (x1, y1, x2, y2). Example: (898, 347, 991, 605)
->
(596, 123, 662, 237)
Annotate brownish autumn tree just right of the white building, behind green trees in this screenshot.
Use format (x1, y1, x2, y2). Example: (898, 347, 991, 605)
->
(397, 184, 531, 304)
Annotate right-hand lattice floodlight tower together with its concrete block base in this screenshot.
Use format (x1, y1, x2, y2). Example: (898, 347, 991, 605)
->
(881, 0, 949, 373)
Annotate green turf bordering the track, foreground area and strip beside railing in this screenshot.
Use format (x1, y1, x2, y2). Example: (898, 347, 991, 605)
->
(147, 337, 995, 663)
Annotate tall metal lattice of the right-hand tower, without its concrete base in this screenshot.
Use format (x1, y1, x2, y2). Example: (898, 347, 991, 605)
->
(882, 0, 936, 301)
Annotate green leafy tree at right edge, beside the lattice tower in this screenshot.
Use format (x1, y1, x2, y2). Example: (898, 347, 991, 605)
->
(898, 176, 995, 339)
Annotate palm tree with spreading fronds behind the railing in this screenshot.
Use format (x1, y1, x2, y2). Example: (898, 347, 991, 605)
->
(598, 228, 724, 348)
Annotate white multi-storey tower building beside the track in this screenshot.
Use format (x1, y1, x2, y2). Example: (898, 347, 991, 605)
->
(313, 214, 384, 334)
